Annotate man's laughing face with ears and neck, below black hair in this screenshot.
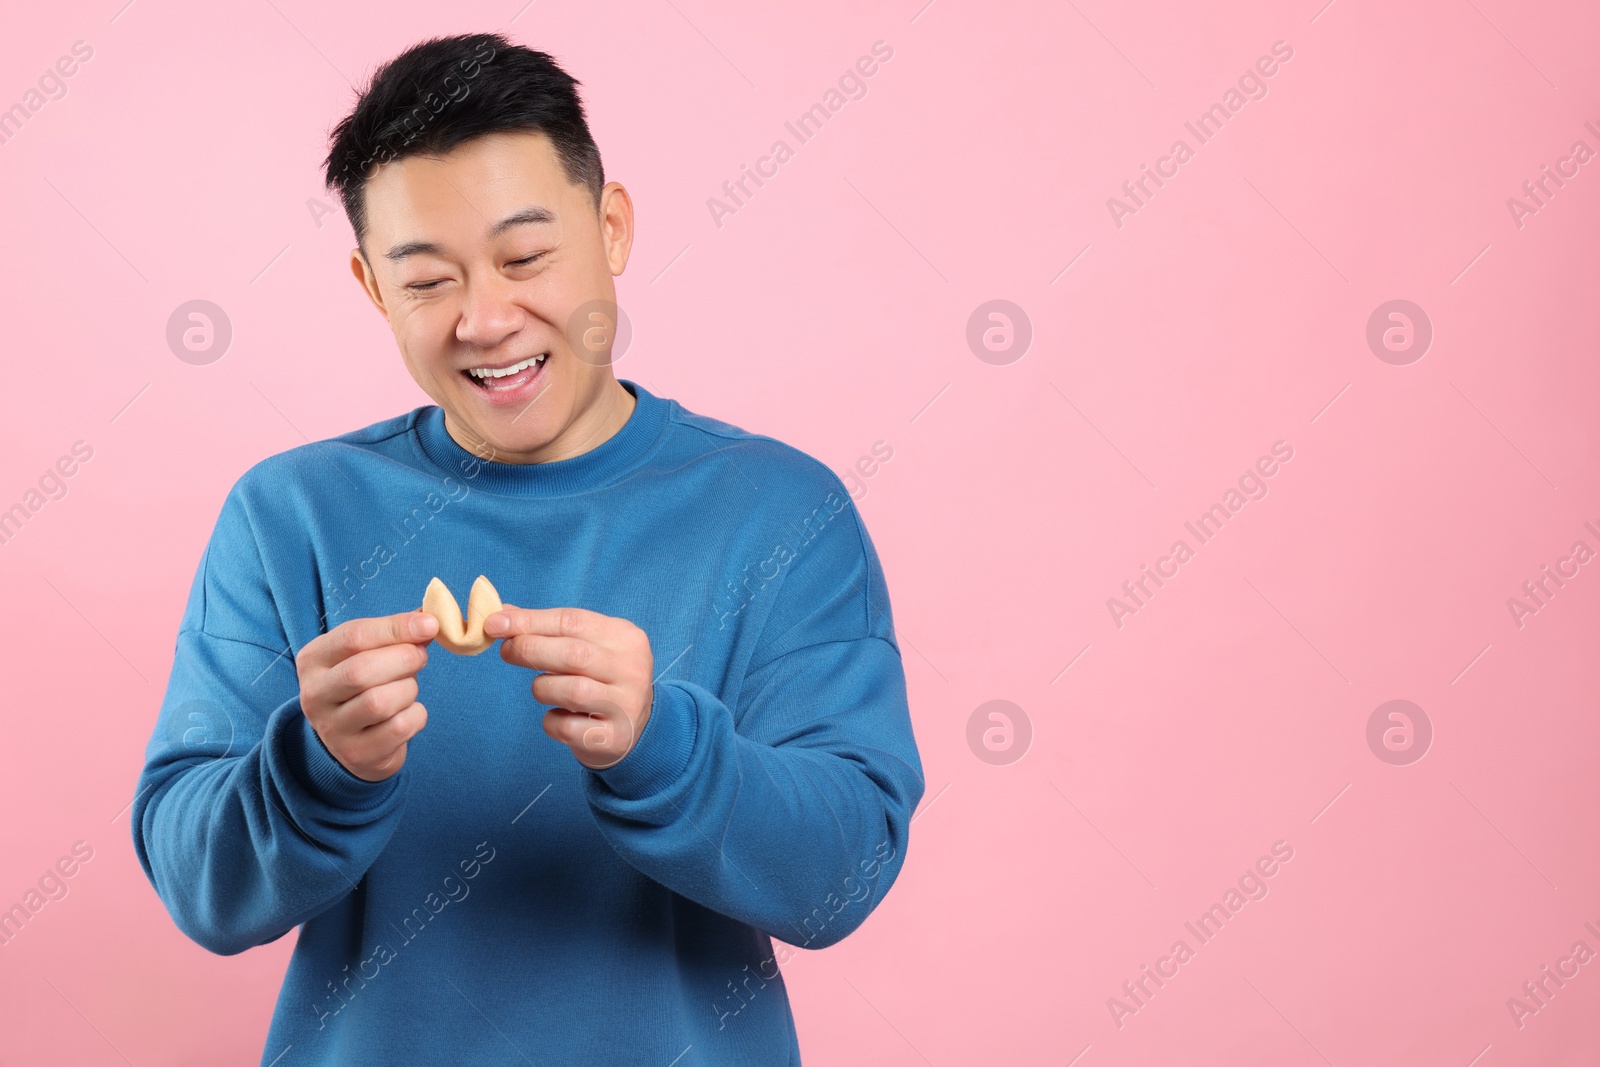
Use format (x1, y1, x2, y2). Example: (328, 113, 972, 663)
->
(350, 133, 634, 462)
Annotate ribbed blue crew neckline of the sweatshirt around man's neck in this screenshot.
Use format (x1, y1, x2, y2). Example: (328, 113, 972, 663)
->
(411, 378, 672, 496)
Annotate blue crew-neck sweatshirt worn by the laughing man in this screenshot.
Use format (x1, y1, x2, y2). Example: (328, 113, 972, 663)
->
(133, 381, 923, 1067)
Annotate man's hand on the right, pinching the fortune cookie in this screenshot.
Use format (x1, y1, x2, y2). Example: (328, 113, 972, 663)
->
(483, 605, 654, 769)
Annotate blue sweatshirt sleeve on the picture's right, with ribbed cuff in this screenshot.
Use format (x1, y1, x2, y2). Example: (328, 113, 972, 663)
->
(584, 478, 923, 949)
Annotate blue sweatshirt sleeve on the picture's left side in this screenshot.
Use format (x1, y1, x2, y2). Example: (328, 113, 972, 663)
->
(131, 475, 408, 955)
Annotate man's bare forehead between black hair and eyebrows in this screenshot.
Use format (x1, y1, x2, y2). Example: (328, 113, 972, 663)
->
(363, 133, 582, 241)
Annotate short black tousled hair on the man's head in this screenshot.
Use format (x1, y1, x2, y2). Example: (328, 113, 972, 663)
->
(323, 34, 605, 250)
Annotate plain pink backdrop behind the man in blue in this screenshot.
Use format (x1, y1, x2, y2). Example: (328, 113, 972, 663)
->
(0, 0, 1600, 1067)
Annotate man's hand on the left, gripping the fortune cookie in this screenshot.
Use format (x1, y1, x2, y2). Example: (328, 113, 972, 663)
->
(294, 611, 438, 782)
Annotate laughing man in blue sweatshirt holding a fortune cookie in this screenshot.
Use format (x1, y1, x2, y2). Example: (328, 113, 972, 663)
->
(133, 35, 923, 1067)
